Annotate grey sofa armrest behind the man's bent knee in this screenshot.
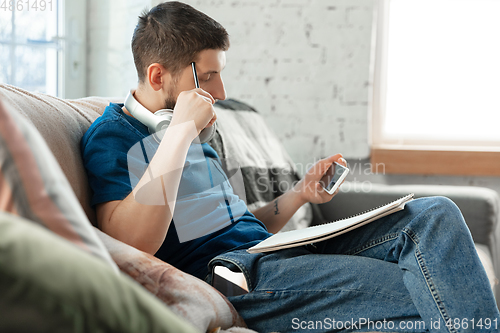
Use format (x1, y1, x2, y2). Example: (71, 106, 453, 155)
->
(319, 182, 500, 300)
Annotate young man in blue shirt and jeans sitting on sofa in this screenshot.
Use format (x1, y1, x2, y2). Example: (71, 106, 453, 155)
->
(82, 2, 500, 332)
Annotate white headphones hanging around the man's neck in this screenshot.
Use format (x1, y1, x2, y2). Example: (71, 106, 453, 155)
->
(125, 90, 217, 143)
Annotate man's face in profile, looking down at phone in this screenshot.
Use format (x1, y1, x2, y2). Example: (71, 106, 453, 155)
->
(165, 49, 226, 110)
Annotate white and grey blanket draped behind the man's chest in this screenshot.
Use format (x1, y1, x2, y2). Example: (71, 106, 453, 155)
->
(209, 99, 322, 231)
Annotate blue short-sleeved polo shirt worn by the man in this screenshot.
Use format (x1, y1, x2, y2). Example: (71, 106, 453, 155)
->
(81, 103, 271, 279)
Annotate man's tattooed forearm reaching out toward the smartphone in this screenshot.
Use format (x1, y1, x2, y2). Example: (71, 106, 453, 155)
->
(252, 189, 306, 233)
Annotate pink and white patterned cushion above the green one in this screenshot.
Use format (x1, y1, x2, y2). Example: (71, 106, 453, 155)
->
(0, 96, 118, 271)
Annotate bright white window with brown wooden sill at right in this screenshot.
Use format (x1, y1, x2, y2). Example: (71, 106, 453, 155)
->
(372, 0, 500, 175)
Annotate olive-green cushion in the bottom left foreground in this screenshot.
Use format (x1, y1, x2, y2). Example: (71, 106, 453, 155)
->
(0, 212, 199, 333)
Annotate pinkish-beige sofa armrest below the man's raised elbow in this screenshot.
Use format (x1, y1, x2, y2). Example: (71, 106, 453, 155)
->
(95, 228, 254, 332)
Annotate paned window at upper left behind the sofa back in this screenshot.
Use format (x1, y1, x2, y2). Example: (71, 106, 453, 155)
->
(0, 0, 86, 98)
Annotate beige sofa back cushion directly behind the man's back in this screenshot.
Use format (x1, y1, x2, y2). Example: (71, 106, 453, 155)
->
(0, 84, 119, 224)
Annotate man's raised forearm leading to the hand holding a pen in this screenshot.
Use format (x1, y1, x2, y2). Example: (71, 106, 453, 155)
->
(98, 120, 197, 254)
